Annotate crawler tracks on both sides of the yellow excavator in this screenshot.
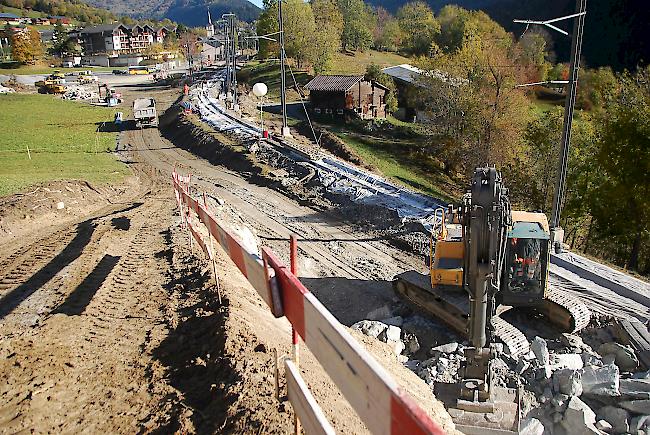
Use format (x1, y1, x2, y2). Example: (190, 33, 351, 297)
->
(393, 271, 590, 357)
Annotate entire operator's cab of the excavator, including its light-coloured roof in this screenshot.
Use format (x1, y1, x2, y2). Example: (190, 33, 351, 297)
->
(497, 211, 550, 307)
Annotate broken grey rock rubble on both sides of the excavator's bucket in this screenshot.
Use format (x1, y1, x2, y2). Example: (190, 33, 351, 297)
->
(352, 316, 650, 435)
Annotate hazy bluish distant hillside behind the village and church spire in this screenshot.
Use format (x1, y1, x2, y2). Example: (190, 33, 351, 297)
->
(81, 0, 261, 26)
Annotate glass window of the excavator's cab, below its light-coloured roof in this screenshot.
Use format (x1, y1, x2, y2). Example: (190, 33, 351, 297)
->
(505, 222, 548, 294)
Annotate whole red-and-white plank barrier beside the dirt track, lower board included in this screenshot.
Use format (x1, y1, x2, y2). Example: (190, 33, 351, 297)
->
(172, 170, 444, 435)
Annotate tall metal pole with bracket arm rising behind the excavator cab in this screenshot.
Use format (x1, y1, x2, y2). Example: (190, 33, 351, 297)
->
(514, 0, 587, 252)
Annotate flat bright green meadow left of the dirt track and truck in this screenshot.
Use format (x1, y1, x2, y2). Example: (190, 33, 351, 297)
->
(0, 94, 128, 195)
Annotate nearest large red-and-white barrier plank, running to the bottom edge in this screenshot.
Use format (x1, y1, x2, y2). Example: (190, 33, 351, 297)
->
(262, 248, 444, 435)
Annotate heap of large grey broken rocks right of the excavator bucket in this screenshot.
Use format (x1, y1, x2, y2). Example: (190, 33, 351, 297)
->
(514, 334, 650, 434)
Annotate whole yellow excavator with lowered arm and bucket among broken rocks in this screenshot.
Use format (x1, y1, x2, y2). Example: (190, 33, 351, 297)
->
(393, 167, 590, 433)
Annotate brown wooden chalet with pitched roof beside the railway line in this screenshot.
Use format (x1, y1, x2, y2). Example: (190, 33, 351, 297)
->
(305, 75, 388, 119)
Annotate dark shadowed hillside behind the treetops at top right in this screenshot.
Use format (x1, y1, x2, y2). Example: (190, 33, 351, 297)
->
(367, 0, 650, 71)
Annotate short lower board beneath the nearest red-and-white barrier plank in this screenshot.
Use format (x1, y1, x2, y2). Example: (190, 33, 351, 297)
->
(284, 359, 336, 435)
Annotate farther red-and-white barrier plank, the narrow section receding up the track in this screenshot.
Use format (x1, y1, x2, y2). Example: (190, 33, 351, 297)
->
(172, 170, 283, 317)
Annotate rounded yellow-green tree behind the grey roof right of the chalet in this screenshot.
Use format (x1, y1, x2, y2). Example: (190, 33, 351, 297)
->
(397, 1, 440, 55)
